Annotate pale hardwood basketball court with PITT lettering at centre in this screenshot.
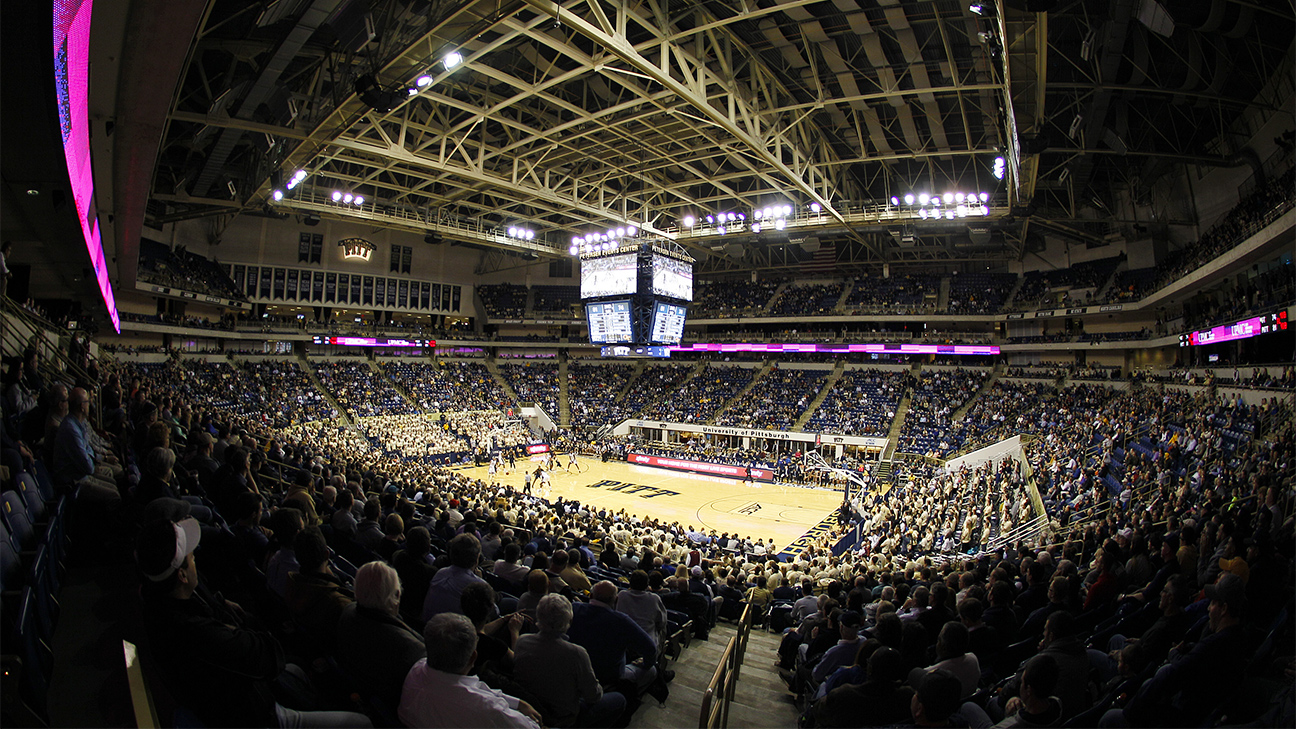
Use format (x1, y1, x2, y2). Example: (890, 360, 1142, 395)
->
(461, 454, 841, 550)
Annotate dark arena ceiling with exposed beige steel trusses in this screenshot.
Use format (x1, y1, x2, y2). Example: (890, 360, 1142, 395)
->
(147, 0, 1296, 271)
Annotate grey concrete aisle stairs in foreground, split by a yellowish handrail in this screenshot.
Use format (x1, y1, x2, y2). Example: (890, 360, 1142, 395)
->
(630, 621, 798, 729)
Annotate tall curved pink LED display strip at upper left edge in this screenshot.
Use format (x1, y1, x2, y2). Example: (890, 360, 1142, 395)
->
(54, 0, 122, 332)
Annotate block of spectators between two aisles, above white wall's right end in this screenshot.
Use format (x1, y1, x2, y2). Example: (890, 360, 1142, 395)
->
(805, 370, 905, 437)
